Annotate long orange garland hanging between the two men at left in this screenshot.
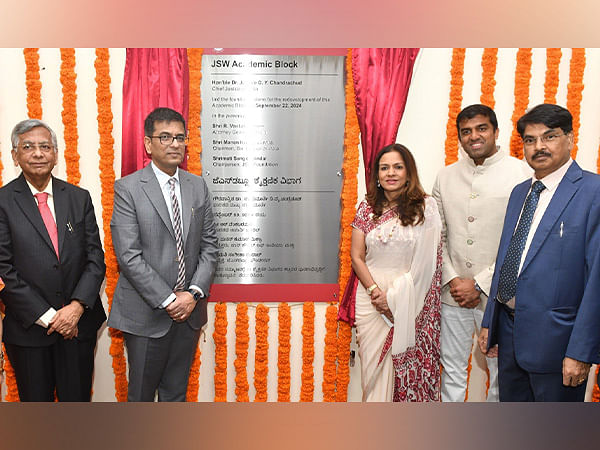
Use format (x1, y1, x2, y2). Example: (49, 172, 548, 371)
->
(94, 48, 127, 402)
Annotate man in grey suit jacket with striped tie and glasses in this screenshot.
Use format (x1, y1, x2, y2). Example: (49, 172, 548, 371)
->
(108, 108, 218, 401)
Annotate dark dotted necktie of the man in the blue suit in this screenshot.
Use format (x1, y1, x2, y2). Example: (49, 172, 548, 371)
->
(498, 181, 546, 303)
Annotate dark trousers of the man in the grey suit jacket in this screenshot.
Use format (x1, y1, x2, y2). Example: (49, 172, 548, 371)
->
(123, 322, 200, 402)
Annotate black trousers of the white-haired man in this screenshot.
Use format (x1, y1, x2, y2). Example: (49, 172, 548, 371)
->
(4, 338, 96, 402)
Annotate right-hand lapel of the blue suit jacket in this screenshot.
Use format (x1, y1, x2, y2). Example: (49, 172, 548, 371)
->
(521, 162, 582, 272)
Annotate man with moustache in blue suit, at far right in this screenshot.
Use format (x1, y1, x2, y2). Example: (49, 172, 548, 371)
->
(479, 104, 600, 401)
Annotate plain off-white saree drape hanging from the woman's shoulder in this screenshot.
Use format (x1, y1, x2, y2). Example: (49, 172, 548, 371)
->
(387, 197, 442, 354)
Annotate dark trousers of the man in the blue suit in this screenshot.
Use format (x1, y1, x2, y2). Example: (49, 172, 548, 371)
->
(498, 308, 586, 402)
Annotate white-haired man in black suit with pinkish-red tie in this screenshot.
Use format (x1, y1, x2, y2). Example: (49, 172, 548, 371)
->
(0, 119, 106, 401)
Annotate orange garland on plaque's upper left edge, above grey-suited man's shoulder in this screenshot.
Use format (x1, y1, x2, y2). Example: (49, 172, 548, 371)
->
(187, 48, 203, 175)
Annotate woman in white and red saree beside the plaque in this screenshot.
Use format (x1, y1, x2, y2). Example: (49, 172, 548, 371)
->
(351, 144, 442, 401)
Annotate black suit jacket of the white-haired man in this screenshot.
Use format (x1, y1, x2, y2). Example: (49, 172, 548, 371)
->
(0, 174, 106, 346)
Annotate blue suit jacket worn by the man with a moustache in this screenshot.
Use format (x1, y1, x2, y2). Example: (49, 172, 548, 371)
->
(482, 162, 600, 373)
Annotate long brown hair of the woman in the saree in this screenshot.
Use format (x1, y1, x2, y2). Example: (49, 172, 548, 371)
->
(367, 144, 426, 226)
